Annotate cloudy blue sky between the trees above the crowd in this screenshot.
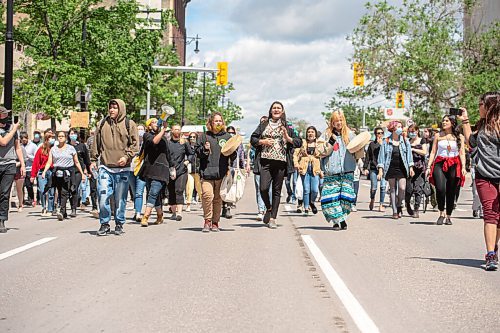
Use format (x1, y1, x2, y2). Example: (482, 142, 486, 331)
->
(186, 0, 400, 135)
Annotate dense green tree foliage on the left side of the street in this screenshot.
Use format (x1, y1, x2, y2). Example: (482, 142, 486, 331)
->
(0, 0, 241, 123)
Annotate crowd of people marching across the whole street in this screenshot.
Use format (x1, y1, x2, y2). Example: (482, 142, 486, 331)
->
(0, 92, 500, 270)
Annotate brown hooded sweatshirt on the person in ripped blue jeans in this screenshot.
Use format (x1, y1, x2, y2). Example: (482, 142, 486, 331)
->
(90, 99, 139, 168)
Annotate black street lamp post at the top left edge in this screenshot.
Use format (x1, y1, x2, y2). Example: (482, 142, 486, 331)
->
(3, 0, 14, 119)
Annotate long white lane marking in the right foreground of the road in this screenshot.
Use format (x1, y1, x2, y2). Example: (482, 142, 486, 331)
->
(302, 235, 379, 333)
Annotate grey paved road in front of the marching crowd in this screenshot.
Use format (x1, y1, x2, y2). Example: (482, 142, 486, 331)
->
(0, 175, 500, 332)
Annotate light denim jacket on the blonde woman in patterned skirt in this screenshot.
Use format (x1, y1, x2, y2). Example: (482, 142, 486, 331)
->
(321, 132, 356, 176)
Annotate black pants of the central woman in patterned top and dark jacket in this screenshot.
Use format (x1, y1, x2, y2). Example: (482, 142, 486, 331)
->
(260, 158, 286, 219)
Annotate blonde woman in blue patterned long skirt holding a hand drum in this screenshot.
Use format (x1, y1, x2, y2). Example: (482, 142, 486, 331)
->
(321, 110, 356, 230)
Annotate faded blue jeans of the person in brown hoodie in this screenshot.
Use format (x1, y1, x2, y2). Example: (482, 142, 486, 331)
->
(97, 168, 130, 224)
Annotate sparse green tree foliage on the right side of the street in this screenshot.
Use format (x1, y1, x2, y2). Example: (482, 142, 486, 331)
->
(330, 0, 500, 125)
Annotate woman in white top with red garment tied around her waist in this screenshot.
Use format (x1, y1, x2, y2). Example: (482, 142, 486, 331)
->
(427, 115, 467, 225)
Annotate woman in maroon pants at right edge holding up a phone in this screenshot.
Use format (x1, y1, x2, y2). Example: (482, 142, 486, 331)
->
(458, 92, 500, 271)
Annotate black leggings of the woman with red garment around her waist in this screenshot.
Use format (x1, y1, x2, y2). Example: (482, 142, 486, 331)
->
(432, 162, 459, 216)
